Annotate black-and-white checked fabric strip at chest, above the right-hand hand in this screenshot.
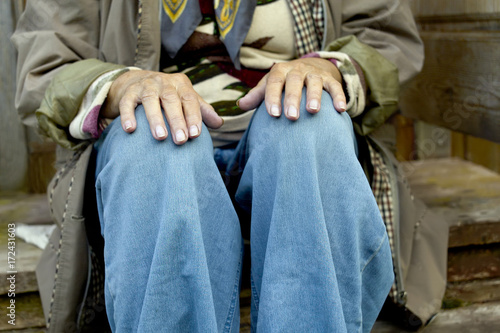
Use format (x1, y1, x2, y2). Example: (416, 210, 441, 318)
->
(288, 0, 324, 57)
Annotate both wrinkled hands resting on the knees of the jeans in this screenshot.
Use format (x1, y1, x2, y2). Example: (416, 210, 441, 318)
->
(101, 58, 346, 145)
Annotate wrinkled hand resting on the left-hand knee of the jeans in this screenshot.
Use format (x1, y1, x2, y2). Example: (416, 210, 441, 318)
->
(101, 70, 223, 145)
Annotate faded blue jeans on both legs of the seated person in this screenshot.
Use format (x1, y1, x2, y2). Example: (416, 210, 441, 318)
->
(96, 89, 393, 332)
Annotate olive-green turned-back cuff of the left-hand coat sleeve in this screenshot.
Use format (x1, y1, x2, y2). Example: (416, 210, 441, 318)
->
(35, 59, 126, 150)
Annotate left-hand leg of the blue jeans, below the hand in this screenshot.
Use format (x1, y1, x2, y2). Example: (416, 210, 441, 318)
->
(96, 112, 242, 332)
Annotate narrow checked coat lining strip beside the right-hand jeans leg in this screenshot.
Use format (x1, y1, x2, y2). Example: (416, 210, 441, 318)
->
(368, 142, 398, 301)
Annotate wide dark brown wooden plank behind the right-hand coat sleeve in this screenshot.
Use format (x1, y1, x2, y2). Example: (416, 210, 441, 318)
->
(400, 31, 500, 142)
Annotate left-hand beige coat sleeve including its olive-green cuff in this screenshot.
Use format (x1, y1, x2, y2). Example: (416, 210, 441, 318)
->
(11, 0, 124, 148)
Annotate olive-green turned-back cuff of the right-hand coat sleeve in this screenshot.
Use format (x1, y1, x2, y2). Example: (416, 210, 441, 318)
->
(326, 36, 399, 135)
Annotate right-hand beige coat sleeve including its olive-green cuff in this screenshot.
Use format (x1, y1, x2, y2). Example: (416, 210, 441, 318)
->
(326, 0, 424, 135)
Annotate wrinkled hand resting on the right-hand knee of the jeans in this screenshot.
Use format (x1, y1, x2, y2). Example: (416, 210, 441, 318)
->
(238, 58, 346, 120)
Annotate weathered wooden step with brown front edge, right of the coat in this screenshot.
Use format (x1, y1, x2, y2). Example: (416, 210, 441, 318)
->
(402, 158, 500, 248)
